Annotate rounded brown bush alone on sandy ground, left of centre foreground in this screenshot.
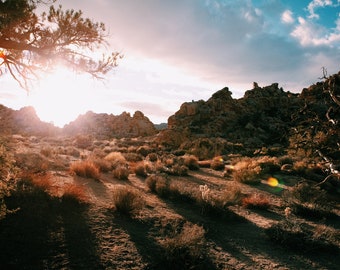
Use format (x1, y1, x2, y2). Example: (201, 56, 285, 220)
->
(112, 185, 145, 216)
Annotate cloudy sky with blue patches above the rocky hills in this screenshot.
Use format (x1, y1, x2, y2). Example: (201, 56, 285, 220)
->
(0, 0, 340, 126)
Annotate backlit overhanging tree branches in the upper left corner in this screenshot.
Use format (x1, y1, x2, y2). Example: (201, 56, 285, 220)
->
(0, 0, 121, 90)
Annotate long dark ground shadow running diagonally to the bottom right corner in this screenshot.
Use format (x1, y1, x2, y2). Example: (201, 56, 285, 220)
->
(162, 196, 339, 269)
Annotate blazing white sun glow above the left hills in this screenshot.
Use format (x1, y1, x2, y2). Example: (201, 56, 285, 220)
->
(28, 66, 94, 127)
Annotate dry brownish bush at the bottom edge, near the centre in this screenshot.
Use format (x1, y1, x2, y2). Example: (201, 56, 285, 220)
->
(160, 222, 207, 269)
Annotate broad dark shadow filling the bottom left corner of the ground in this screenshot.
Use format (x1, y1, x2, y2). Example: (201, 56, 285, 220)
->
(0, 186, 102, 269)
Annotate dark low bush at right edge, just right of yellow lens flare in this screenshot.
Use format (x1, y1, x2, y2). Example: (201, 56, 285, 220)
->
(282, 182, 334, 218)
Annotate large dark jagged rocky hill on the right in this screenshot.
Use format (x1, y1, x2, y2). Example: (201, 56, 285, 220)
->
(157, 72, 340, 159)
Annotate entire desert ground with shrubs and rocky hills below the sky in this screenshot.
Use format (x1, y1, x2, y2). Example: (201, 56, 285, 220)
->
(0, 73, 340, 270)
